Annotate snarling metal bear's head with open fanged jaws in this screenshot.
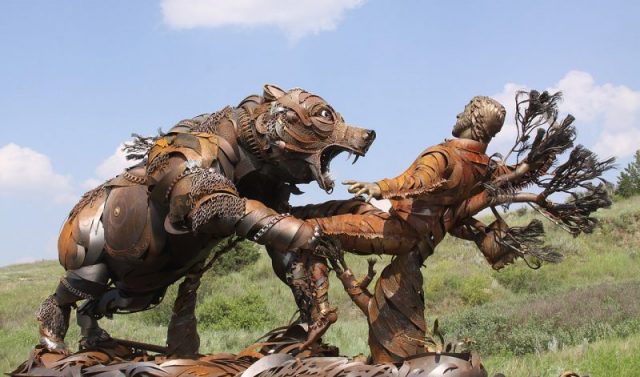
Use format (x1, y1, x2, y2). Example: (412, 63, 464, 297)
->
(239, 85, 375, 191)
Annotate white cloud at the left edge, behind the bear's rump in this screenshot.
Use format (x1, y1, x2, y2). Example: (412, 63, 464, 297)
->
(0, 143, 76, 203)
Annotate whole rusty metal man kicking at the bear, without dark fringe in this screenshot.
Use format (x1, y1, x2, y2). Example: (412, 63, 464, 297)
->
(303, 97, 515, 362)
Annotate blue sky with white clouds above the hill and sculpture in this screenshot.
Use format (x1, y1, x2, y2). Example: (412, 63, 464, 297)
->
(0, 0, 640, 265)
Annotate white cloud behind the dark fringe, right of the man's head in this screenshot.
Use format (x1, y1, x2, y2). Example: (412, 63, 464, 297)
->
(492, 71, 640, 159)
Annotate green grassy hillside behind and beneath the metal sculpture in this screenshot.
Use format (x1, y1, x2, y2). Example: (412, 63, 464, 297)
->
(0, 197, 640, 376)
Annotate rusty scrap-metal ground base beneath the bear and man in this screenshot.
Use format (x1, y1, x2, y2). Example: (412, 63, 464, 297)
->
(10, 325, 487, 377)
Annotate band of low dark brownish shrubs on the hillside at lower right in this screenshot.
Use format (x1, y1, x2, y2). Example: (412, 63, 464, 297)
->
(440, 282, 640, 355)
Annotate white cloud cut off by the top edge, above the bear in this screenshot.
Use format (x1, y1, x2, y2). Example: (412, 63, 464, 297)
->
(161, 0, 366, 41)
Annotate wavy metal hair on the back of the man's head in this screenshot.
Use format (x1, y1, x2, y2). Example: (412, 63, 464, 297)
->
(468, 96, 507, 142)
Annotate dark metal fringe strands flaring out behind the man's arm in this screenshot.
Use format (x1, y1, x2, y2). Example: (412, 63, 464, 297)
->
(484, 90, 615, 239)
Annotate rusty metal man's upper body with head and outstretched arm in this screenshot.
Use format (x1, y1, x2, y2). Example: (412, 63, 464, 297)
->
(345, 96, 508, 256)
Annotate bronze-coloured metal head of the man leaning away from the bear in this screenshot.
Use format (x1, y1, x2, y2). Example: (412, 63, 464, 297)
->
(451, 96, 506, 143)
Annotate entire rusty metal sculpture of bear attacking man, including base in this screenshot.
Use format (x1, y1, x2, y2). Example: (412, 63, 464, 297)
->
(12, 86, 613, 376)
